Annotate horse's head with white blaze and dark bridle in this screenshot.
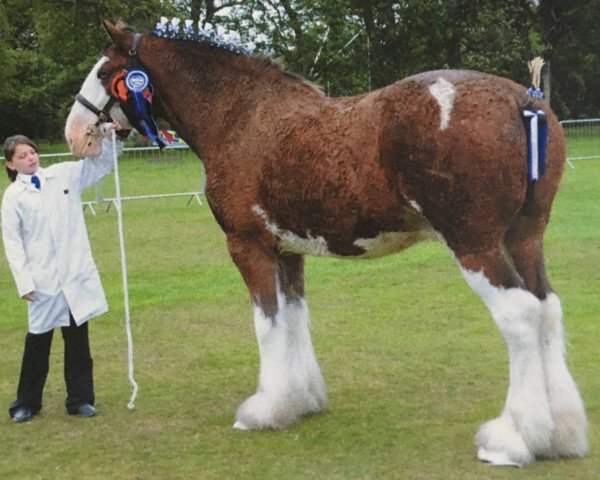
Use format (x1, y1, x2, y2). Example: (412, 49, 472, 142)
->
(65, 21, 133, 156)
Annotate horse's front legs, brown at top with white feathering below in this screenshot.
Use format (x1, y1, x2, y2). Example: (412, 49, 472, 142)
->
(228, 236, 327, 430)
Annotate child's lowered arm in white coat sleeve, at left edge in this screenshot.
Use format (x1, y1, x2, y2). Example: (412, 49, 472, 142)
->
(2, 195, 35, 297)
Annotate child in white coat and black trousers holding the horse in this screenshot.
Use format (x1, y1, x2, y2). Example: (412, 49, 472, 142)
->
(2, 123, 122, 423)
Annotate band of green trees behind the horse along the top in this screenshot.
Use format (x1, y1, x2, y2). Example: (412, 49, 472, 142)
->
(0, 0, 600, 138)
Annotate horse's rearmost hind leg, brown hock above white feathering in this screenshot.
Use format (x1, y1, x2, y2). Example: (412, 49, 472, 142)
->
(505, 217, 587, 458)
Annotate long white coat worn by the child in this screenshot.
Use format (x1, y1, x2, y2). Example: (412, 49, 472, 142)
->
(2, 139, 122, 334)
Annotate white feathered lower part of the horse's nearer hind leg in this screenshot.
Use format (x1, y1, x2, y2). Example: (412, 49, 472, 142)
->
(463, 270, 554, 465)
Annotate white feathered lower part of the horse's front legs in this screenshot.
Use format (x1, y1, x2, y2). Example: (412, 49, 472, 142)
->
(233, 282, 327, 430)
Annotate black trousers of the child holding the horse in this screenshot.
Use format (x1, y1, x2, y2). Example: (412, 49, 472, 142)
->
(8, 316, 95, 417)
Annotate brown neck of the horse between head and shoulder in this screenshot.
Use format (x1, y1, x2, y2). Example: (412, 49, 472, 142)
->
(143, 39, 322, 162)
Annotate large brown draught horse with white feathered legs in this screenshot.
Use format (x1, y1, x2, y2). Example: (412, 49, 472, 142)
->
(65, 21, 588, 466)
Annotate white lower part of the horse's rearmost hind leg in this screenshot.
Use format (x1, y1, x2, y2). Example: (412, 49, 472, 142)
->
(540, 294, 588, 458)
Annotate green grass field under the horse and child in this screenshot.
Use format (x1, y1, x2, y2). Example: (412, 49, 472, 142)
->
(0, 151, 600, 480)
